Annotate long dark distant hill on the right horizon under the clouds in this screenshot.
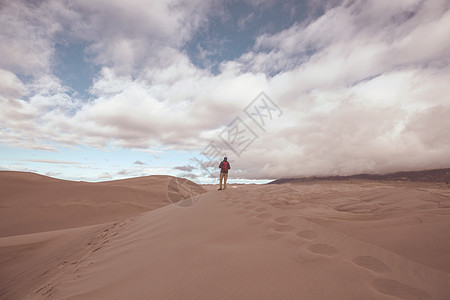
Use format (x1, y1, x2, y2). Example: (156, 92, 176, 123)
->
(269, 168, 450, 184)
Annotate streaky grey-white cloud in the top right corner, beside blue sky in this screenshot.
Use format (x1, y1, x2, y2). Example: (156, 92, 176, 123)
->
(248, 1, 450, 77)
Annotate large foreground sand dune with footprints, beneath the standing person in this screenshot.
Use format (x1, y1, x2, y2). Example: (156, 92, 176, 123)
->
(12, 182, 450, 299)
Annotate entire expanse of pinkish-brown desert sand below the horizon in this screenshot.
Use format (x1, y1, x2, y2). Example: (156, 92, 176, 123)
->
(0, 172, 450, 299)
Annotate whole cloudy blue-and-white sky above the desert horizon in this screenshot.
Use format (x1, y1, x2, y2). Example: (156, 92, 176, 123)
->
(0, 0, 450, 183)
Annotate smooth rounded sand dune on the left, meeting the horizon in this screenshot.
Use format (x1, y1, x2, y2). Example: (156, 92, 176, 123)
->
(0, 171, 199, 237)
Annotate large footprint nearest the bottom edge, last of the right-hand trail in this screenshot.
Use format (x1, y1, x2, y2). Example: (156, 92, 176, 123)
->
(372, 278, 430, 300)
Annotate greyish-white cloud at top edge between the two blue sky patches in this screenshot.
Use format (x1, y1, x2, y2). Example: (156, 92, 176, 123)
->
(65, 0, 214, 75)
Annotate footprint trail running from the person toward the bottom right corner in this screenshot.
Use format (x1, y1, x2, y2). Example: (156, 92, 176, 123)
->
(219, 195, 429, 299)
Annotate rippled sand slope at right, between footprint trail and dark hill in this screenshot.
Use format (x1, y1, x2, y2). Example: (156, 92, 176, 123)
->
(265, 181, 450, 273)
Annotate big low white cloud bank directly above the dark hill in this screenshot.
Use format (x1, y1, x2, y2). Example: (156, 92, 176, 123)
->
(235, 67, 450, 178)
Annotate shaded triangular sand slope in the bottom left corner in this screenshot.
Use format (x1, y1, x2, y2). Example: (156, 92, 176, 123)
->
(0, 224, 109, 299)
